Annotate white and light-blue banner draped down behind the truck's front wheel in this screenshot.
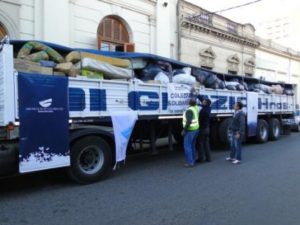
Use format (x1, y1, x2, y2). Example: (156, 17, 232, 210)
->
(110, 112, 137, 162)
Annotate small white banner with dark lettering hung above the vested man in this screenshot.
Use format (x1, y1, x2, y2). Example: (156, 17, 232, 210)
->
(168, 83, 191, 112)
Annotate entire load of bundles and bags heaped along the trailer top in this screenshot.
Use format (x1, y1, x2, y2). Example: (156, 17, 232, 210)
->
(14, 41, 294, 95)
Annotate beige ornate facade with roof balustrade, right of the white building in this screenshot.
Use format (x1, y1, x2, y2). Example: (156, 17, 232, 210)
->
(178, 0, 258, 76)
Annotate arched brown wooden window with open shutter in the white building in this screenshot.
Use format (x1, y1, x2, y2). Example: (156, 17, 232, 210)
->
(97, 16, 134, 52)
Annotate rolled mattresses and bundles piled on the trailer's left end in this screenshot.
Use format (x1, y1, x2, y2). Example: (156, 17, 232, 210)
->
(15, 41, 134, 79)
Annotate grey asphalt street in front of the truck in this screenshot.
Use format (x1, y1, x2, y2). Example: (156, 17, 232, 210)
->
(0, 133, 300, 225)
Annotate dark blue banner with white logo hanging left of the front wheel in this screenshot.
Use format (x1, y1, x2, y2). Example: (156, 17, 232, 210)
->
(18, 73, 70, 172)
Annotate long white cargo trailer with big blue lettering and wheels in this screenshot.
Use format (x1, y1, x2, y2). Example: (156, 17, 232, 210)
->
(0, 40, 295, 183)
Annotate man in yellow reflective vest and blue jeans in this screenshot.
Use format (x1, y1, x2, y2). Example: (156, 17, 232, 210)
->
(182, 99, 199, 167)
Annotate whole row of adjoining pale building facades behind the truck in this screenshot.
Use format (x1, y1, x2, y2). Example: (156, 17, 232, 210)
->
(0, 0, 300, 101)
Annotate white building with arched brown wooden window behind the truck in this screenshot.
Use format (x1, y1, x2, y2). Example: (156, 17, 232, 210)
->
(0, 0, 176, 57)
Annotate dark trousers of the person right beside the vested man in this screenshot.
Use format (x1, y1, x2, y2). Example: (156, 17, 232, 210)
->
(197, 128, 211, 161)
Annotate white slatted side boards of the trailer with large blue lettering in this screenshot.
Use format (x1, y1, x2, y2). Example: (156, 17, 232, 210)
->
(0, 45, 295, 126)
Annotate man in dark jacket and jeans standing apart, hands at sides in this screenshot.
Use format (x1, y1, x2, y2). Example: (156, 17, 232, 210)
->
(226, 102, 245, 164)
